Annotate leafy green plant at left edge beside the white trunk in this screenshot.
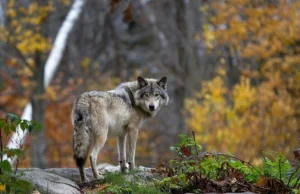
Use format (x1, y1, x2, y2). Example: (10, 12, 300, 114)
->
(0, 113, 41, 193)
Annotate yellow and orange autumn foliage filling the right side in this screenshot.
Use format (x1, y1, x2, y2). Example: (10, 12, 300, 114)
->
(186, 0, 300, 163)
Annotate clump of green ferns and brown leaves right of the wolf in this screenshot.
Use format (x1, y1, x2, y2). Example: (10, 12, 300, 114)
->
(154, 133, 300, 193)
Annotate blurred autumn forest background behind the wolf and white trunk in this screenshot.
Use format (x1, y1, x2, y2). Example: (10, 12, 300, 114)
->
(0, 0, 300, 168)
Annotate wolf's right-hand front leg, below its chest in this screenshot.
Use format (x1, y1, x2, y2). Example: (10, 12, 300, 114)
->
(128, 129, 138, 171)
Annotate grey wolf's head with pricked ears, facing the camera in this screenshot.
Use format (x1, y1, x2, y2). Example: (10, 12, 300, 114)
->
(134, 77, 169, 116)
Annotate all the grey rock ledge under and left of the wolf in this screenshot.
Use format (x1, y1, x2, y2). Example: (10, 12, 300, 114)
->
(18, 163, 160, 194)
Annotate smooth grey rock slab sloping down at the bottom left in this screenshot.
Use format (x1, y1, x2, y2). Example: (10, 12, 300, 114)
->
(19, 169, 80, 194)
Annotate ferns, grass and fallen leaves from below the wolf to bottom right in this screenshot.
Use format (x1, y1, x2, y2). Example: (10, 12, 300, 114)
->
(78, 133, 300, 194)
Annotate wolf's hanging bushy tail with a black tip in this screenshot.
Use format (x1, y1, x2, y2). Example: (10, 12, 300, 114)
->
(72, 100, 91, 167)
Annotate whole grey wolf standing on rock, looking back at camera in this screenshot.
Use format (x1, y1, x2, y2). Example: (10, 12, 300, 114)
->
(71, 77, 169, 182)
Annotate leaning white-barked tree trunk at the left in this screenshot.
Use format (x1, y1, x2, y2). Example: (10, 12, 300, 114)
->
(3, 0, 86, 165)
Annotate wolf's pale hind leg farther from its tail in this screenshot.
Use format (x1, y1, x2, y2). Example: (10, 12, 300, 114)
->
(90, 130, 107, 179)
